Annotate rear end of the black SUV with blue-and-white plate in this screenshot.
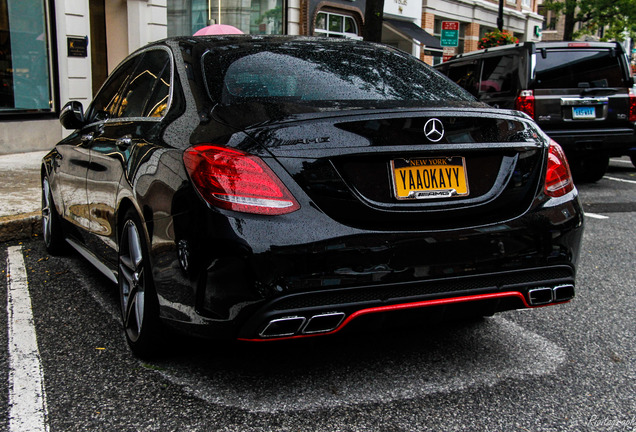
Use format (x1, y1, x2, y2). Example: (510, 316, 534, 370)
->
(516, 42, 636, 181)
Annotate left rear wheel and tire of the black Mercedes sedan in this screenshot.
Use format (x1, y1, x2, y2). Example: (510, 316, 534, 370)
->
(117, 211, 162, 358)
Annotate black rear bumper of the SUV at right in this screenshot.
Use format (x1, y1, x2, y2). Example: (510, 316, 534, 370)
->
(544, 127, 636, 157)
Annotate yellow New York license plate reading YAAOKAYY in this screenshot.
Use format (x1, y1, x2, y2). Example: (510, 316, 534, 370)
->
(391, 156, 469, 200)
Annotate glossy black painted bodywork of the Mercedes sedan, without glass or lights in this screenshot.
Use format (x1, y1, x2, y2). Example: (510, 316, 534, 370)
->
(42, 37, 583, 339)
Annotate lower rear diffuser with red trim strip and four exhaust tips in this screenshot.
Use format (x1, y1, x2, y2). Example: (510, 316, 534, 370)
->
(238, 266, 574, 341)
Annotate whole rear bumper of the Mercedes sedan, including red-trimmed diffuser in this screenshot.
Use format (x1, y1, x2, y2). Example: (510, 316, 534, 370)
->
(155, 190, 583, 340)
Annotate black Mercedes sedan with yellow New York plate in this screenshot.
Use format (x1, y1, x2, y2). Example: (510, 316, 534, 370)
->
(42, 36, 583, 356)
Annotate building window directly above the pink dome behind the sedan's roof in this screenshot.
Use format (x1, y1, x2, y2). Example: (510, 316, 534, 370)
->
(168, 0, 285, 36)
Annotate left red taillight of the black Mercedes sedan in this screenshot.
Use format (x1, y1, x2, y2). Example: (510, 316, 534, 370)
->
(183, 145, 300, 215)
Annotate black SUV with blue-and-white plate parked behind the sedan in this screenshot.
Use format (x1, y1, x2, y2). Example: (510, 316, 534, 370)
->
(436, 42, 636, 181)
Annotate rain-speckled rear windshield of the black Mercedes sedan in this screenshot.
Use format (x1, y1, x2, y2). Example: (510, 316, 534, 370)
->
(202, 41, 475, 106)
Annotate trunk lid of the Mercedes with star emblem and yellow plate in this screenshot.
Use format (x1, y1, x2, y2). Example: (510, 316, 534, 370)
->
(247, 109, 545, 229)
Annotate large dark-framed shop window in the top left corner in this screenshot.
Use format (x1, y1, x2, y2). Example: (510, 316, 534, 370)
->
(0, 0, 54, 114)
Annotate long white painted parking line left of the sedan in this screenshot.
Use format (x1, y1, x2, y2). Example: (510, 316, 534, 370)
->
(7, 246, 49, 432)
